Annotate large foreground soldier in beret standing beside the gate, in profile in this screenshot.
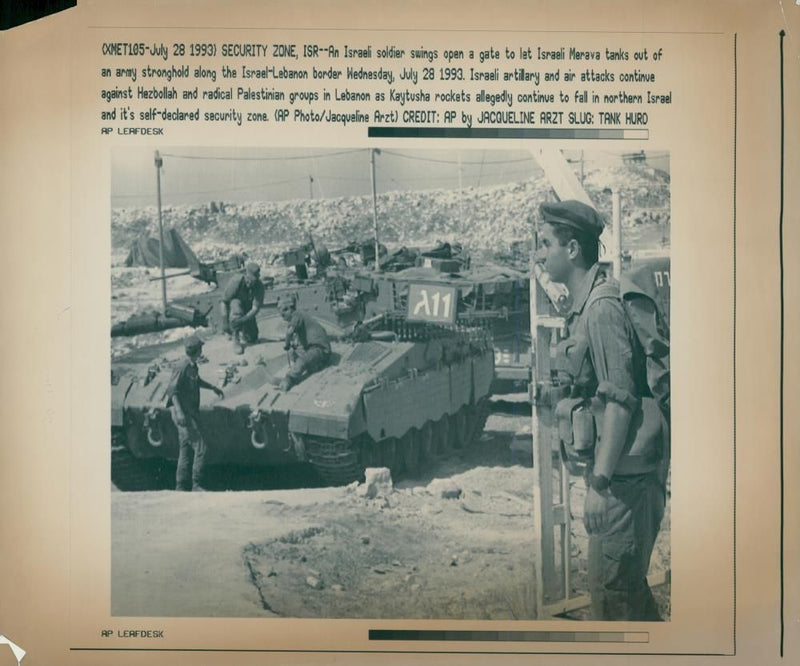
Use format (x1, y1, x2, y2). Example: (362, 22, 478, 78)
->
(536, 201, 669, 620)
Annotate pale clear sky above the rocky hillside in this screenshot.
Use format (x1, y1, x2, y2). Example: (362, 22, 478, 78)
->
(111, 147, 669, 208)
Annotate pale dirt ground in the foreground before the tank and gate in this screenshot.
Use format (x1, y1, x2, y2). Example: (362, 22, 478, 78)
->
(111, 396, 669, 620)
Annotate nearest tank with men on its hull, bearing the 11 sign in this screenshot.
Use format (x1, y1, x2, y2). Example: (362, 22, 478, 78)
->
(111, 264, 494, 489)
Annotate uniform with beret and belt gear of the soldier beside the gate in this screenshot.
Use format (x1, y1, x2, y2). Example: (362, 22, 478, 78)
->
(542, 202, 668, 620)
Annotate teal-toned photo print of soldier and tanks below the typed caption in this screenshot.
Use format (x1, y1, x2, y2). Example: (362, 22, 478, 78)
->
(109, 142, 672, 621)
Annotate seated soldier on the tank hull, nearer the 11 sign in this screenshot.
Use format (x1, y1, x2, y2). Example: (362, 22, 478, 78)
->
(280, 298, 331, 391)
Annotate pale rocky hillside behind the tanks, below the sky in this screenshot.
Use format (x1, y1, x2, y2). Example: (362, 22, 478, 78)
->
(111, 165, 670, 260)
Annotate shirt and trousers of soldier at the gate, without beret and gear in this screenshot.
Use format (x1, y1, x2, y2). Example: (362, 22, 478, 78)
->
(562, 264, 665, 620)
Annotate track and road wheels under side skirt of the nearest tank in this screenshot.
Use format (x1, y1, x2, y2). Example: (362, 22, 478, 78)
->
(304, 398, 489, 485)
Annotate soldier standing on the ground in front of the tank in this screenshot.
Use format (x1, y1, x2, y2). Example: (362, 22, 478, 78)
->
(167, 336, 224, 490)
